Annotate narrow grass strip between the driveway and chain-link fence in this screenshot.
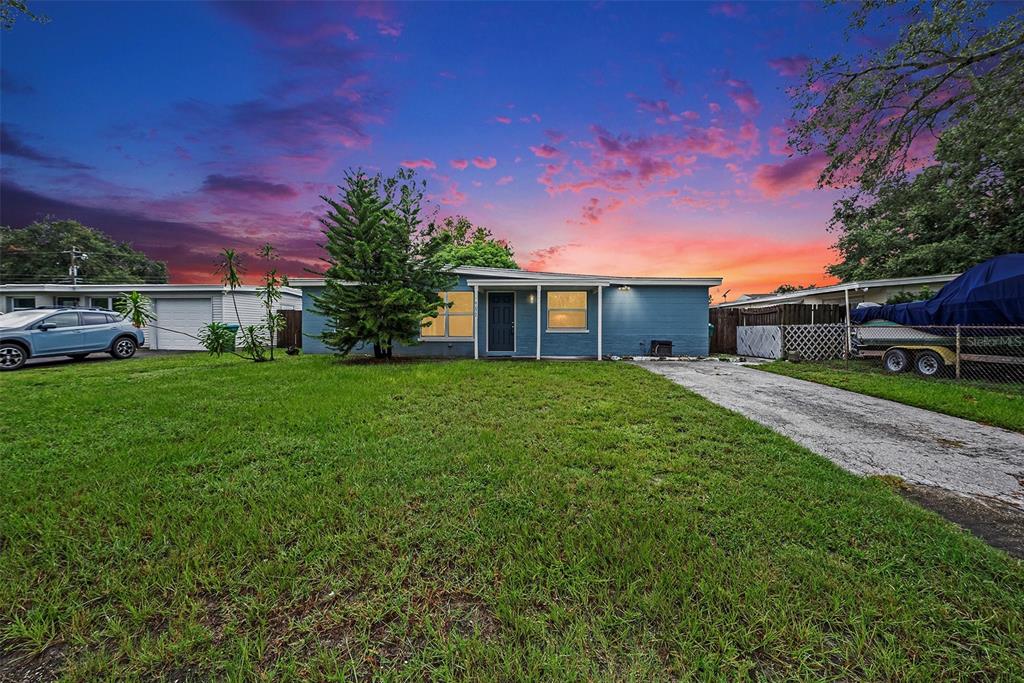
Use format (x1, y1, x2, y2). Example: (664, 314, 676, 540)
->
(752, 360, 1024, 432)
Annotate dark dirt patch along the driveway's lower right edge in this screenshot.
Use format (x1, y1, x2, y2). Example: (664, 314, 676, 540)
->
(896, 482, 1024, 559)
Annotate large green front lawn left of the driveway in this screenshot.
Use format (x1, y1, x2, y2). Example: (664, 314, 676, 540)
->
(0, 355, 1024, 681)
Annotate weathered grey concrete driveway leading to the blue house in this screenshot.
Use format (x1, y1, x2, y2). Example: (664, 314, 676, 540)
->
(637, 360, 1024, 557)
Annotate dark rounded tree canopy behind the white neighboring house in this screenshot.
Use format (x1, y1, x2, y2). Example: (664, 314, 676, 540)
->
(0, 219, 167, 284)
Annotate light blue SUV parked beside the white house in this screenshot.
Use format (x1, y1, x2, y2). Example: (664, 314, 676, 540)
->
(0, 308, 144, 371)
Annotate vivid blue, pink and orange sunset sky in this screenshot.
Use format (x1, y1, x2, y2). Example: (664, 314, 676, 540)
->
(0, 2, 884, 299)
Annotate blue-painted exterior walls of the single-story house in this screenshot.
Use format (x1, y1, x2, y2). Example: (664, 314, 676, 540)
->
(302, 276, 709, 358)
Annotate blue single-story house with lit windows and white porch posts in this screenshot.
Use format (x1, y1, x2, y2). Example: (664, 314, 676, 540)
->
(289, 266, 722, 358)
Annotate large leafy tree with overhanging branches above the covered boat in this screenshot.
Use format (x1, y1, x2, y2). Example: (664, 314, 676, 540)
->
(791, 0, 1024, 281)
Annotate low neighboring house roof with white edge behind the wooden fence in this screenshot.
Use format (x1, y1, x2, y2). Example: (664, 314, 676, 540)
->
(716, 273, 959, 308)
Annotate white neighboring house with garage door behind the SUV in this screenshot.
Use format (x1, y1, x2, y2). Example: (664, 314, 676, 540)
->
(0, 285, 302, 351)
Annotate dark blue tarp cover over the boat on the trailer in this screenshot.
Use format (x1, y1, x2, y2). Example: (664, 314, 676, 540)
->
(850, 254, 1024, 328)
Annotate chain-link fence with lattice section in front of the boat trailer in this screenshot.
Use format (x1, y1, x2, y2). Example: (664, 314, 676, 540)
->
(780, 323, 1024, 392)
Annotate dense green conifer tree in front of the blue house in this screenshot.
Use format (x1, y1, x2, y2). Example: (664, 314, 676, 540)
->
(313, 169, 454, 358)
